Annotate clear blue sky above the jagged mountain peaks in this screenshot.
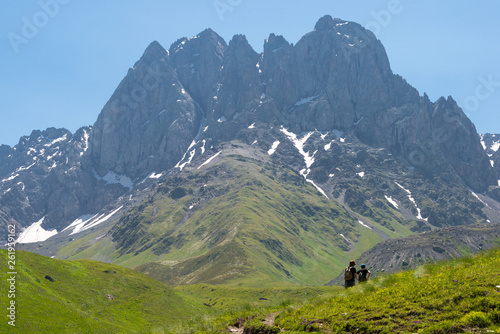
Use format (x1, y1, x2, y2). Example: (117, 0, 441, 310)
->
(0, 0, 500, 146)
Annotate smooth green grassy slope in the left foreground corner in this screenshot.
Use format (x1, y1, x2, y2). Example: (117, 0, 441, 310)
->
(0, 251, 207, 333)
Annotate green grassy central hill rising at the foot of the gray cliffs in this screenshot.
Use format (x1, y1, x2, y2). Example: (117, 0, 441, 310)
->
(122, 157, 390, 286)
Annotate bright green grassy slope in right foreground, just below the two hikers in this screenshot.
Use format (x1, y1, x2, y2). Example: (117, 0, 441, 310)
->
(277, 249, 500, 333)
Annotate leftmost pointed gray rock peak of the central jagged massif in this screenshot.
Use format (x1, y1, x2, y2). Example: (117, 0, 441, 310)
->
(90, 42, 201, 179)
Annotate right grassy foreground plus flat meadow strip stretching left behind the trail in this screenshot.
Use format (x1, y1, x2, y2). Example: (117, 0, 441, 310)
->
(171, 249, 500, 334)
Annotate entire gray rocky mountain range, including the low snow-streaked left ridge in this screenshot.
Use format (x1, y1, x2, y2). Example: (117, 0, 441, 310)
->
(0, 16, 500, 245)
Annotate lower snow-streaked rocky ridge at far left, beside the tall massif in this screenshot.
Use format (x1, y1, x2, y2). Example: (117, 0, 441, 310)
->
(0, 127, 127, 235)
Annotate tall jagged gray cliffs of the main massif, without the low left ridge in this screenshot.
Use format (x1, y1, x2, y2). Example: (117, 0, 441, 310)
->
(91, 16, 495, 192)
